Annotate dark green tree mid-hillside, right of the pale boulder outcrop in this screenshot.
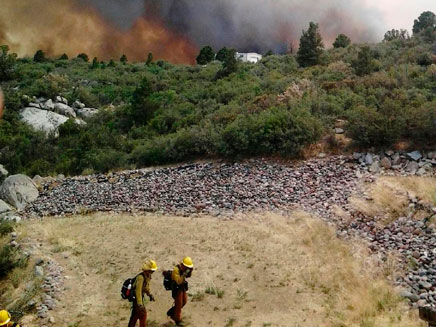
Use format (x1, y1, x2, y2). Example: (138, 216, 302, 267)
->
(130, 78, 159, 126)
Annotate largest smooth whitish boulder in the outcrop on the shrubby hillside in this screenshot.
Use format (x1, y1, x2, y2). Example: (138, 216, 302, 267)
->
(20, 108, 68, 137)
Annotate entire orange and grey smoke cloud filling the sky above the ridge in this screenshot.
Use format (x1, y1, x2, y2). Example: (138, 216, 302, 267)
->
(0, 0, 381, 63)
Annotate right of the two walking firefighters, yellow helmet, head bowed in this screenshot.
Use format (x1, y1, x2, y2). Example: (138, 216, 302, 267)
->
(167, 257, 194, 326)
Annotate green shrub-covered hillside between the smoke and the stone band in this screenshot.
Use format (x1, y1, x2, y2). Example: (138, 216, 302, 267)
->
(0, 20, 436, 176)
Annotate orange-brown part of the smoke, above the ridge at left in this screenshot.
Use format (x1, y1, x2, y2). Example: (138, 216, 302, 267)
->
(0, 0, 197, 63)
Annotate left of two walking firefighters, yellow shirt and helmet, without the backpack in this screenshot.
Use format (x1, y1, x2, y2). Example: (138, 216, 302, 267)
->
(128, 260, 157, 327)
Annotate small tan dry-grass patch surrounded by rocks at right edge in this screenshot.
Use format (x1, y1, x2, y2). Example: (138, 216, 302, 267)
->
(350, 176, 436, 223)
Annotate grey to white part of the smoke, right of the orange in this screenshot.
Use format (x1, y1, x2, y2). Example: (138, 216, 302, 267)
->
(80, 0, 383, 52)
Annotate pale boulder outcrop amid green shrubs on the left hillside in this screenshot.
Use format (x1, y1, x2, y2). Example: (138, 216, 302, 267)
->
(20, 96, 98, 137)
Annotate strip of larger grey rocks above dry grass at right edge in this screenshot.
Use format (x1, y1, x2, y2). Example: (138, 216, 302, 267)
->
(353, 151, 436, 176)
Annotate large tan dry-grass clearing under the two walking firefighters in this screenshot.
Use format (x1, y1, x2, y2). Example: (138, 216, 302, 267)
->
(16, 212, 420, 327)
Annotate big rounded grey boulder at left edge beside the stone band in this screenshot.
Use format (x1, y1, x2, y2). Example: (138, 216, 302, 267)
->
(0, 175, 39, 210)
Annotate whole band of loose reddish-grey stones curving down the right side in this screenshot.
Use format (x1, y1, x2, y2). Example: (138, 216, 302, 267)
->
(19, 154, 436, 307)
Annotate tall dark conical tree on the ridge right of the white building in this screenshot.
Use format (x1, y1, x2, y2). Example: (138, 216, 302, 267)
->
(297, 22, 324, 67)
